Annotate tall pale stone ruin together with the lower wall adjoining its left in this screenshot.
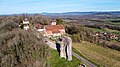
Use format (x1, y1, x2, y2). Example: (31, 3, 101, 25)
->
(46, 36, 72, 61)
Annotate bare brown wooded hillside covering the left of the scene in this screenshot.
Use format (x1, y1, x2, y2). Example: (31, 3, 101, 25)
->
(0, 16, 49, 67)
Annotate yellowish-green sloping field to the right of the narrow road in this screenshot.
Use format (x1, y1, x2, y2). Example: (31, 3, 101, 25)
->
(73, 42, 120, 67)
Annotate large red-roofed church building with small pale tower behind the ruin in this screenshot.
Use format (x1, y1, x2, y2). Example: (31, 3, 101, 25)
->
(35, 21, 65, 36)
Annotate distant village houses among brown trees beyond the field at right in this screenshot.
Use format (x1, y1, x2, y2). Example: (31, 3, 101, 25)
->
(91, 29, 120, 51)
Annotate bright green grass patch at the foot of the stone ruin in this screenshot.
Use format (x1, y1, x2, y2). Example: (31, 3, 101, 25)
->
(49, 49, 81, 67)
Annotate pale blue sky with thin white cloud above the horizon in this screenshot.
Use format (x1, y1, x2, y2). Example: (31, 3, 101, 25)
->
(0, 0, 120, 14)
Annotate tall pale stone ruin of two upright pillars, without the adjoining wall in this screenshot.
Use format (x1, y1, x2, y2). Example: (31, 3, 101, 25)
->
(60, 36, 72, 61)
